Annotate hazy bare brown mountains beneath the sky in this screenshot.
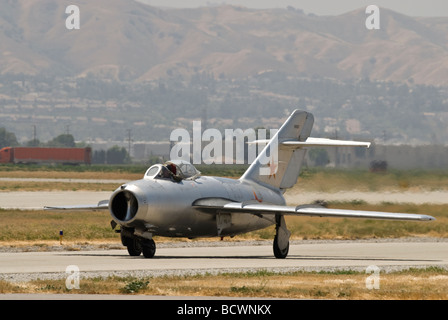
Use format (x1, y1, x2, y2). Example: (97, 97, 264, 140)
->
(0, 0, 448, 86)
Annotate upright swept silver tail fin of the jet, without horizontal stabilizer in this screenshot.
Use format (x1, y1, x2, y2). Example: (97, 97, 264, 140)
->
(240, 110, 314, 189)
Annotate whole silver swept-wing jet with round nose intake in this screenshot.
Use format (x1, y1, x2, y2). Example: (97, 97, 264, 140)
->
(46, 110, 434, 258)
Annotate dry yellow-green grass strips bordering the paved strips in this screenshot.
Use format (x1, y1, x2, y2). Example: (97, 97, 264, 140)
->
(0, 169, 448, 299)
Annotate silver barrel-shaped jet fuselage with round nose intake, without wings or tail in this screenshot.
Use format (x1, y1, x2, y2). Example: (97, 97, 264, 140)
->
(109, 176, 285, 238)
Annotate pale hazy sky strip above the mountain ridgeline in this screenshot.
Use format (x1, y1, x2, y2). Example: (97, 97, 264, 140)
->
(139, 0, 448, 17)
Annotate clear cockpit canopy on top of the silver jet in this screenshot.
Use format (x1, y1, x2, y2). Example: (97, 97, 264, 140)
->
(144, 160, 201, 181)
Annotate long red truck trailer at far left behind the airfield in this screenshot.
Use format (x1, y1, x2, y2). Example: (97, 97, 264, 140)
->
(0, 147, 92, 164)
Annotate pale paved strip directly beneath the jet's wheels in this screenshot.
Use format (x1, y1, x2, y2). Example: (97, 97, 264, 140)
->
(0, 240, 448, 281)
